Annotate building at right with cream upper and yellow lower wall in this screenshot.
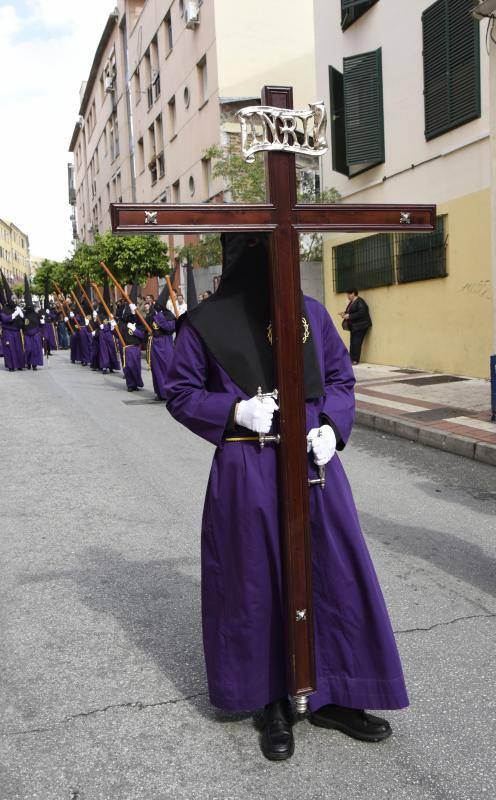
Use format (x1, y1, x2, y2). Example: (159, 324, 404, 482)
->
(314, 0, 493, 377)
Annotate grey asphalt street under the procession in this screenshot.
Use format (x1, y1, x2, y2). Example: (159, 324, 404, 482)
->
(0, 353, 496, 800)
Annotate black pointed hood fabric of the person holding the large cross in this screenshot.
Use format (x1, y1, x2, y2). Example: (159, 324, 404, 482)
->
(188, 233, 324, 400)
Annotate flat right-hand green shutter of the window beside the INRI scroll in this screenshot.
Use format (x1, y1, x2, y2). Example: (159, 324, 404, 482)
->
(343, 48, 385, 175)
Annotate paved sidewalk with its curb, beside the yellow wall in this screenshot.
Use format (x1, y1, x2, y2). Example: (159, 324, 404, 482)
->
(354, 364, 496, 465)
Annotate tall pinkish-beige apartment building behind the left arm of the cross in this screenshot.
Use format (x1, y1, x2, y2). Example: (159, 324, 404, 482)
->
(69, 0, 315, 290)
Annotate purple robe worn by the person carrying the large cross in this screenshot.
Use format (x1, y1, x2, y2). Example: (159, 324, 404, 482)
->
(167, 297, 408, 711)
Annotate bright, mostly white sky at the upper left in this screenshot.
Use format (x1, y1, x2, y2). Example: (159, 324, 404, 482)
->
(0, 0, 115, 260)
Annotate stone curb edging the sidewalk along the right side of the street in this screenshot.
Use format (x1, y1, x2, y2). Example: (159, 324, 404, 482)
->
(355, 408, 496, 466)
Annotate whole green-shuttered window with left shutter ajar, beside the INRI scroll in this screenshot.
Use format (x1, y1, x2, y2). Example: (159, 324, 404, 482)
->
(330, 48, 385, 177)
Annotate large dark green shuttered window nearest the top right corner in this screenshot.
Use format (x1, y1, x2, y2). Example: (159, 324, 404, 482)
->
(422, 0, 481, 140)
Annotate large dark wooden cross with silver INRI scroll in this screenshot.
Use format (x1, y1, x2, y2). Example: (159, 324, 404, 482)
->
(111, 86, 436, 710)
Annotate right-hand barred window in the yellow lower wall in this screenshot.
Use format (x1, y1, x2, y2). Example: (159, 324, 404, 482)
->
(398, 217, 447, 283)
